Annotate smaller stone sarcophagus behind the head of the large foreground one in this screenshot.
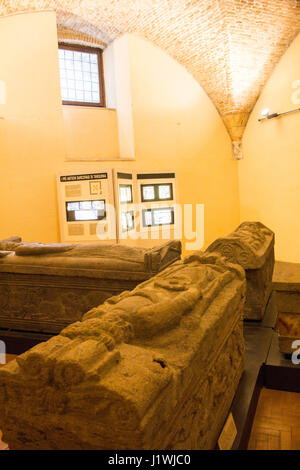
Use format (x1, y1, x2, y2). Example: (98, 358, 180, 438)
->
(206, 222, 275, 320)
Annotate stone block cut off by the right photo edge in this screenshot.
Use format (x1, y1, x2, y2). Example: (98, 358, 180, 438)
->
(273, 261, 300, 354)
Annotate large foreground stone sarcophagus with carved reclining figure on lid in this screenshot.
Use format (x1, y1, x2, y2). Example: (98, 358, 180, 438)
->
(0, 252, 246, 449)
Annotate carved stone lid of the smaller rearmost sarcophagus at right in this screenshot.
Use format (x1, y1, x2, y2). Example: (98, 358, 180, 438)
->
(206, 222, 275, 269)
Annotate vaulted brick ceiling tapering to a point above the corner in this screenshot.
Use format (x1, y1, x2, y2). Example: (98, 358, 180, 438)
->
(0, 0, 300, 140)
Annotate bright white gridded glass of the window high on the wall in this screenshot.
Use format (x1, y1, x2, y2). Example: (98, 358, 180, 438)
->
(59, 48, 100, 104)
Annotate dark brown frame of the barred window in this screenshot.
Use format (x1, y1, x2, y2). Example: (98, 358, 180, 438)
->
(58, 42, 105, 108)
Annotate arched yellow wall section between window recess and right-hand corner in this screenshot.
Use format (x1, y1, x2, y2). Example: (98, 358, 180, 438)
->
(128, 35, 239, 250)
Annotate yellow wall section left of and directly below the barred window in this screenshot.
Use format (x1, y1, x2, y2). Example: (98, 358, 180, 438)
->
(0, 12, 118, 242)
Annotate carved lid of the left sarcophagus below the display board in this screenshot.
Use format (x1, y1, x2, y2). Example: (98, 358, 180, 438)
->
(0, 239, 181, 280)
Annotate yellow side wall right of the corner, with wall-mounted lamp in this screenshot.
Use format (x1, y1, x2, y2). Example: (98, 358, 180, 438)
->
(239, 31, 300, 263)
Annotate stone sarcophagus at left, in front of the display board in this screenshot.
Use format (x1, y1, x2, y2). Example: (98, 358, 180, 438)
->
(0, 237, 181, 333)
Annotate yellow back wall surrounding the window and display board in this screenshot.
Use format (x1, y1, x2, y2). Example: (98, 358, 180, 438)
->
(0, 12, 239, 250)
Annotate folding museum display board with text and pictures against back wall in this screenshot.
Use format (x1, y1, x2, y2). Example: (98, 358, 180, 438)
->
(57, 168, 177, 245)
